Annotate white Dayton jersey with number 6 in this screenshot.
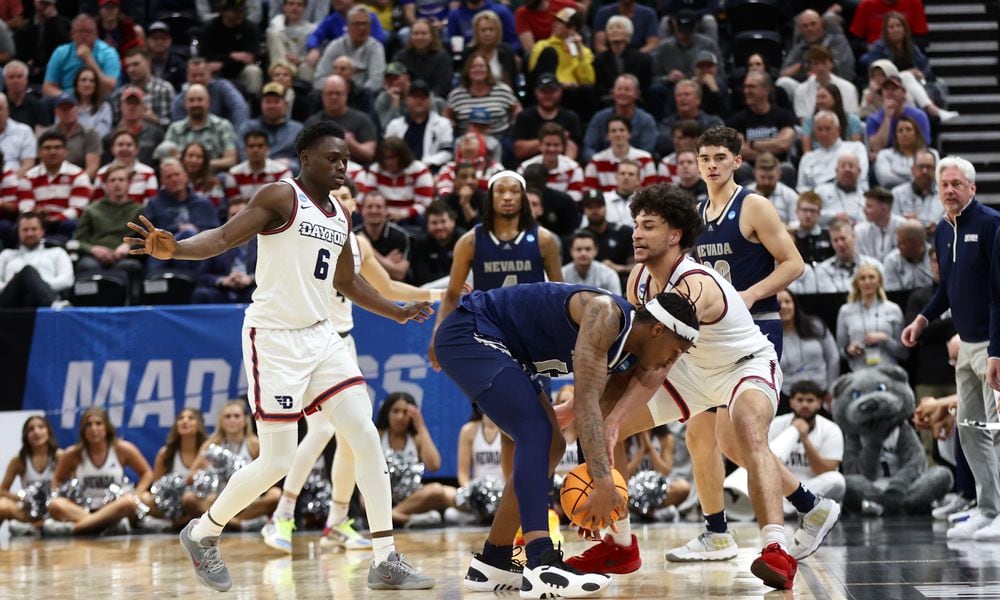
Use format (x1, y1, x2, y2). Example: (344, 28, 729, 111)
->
(244, 178, 351, 329)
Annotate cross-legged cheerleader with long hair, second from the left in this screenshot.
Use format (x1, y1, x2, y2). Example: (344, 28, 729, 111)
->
(42, 406, 153, 536)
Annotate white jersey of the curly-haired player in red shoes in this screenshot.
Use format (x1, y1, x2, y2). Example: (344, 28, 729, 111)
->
(635, 256, 773, 369)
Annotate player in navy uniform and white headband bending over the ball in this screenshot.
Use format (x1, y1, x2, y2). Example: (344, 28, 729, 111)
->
(435, 283, 698, 598)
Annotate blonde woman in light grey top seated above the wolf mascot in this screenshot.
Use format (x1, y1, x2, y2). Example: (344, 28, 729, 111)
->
(837, 265, 907, 371)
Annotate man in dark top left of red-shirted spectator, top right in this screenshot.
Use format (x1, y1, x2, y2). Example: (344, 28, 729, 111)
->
(775, 9, 854, 90)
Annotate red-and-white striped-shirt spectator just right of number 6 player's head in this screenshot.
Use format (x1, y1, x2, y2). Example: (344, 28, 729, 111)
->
(358, 137, 434, 222)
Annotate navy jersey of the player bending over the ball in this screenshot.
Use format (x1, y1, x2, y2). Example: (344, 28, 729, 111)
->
(459, 283, 635, 377)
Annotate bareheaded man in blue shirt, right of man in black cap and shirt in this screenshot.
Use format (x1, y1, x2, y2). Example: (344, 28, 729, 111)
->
(579, 73, 656, 163)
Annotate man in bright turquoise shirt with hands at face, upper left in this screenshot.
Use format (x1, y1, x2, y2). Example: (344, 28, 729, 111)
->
(42, 14, 121, 98)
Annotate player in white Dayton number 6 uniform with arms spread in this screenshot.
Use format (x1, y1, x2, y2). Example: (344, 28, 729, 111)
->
(125, 121, 434, 591)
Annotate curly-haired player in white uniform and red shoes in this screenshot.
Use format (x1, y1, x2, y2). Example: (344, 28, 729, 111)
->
(567, 185, 825, 589)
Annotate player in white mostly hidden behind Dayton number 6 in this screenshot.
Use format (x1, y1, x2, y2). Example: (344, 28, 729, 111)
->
(261, 181, 443, 554)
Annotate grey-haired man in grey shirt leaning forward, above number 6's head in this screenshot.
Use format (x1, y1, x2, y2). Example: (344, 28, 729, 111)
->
(314, 5, 385, 94)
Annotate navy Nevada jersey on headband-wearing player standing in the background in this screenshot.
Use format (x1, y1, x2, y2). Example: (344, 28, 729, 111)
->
(472, 225, 545, 290)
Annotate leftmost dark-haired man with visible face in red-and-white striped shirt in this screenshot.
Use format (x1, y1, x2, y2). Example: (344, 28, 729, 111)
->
(17, 130, 92, 221)
